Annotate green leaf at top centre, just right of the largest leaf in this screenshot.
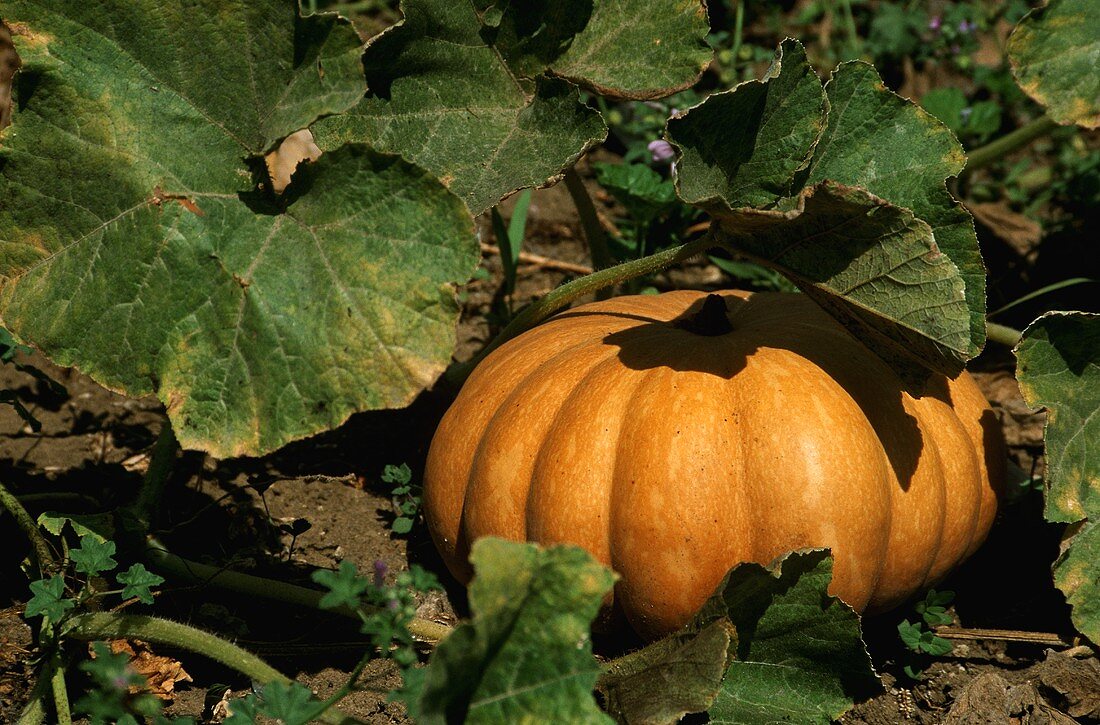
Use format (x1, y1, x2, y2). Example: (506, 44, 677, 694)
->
(312, 0, 712, 213)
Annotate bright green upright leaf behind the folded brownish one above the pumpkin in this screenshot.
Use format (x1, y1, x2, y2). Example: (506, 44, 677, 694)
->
(806, 62, 986, 359)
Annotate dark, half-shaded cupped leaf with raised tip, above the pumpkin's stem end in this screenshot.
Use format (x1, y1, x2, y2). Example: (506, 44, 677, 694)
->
(668, 40, 826, 210)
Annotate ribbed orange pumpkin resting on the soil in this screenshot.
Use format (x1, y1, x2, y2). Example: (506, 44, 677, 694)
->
(424, 292, 1004, 637)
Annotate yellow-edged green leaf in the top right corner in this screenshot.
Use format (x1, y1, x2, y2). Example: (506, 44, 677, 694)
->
(1008, 0, 1100, 129)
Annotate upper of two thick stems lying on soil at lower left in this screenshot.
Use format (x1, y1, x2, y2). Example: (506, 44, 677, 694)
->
(145, 540, 451, 644)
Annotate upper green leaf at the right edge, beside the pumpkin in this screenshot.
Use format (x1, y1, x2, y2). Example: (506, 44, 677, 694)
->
(1016, 312, 1100, 523)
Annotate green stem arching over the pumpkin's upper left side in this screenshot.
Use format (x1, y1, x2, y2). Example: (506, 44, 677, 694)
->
(446, 234, 717, 386)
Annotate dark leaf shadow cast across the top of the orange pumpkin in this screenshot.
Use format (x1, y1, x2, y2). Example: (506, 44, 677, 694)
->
(561, 293, 999, 491)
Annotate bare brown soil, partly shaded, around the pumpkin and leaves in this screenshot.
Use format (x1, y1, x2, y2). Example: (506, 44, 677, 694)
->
(0, 172, 1100, 725)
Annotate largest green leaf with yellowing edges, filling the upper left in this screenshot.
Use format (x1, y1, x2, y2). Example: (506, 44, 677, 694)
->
(0, 0, 477, 455)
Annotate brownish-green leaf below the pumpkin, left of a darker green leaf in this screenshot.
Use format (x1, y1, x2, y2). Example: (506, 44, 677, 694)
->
(596, 619, 732, 725)
